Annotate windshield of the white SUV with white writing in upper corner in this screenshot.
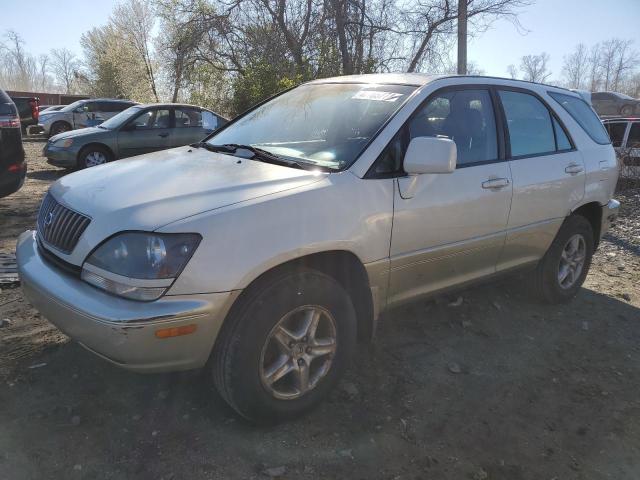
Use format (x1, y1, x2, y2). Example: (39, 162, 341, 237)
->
(208, 83, 416, 169)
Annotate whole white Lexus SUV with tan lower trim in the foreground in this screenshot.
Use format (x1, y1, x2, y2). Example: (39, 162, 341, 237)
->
(17, 74, 619, 421)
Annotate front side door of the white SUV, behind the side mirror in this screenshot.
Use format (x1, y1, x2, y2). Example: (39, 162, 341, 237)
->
(389, 87, 512, 304)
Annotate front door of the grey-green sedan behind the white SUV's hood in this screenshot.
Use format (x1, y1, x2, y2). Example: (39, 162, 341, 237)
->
(118, 108, 173, 158)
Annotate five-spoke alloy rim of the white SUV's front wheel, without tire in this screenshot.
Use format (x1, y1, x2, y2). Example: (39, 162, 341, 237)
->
(260, 305, 337, 400)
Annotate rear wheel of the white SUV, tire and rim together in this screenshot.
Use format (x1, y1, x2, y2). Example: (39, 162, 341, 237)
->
(532, 215, 594, 304)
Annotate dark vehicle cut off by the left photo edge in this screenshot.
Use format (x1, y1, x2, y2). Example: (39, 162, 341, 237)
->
(0, 90, 27, 197)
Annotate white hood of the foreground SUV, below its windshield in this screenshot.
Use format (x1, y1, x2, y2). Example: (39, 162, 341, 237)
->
(51, 147, 329, 234)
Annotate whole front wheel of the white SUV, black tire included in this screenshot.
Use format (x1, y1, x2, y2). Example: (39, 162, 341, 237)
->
(209, 269, 356, 424)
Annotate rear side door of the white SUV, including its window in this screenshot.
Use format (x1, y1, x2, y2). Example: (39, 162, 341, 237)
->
(498, 87, 586, 270)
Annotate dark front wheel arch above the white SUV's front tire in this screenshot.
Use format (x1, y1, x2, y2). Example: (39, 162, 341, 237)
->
(227, 250, 375, 341)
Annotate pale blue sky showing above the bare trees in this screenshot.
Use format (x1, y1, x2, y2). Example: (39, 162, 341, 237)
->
(0, 0, 640, 78)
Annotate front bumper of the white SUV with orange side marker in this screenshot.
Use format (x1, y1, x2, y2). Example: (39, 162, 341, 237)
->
(16, 231, 239, 372)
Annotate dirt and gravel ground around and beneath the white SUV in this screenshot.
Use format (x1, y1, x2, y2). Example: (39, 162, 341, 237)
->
(0, 142, 640, 480)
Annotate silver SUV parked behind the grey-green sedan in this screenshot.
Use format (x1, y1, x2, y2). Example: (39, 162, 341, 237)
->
(38, 98, 137, 136)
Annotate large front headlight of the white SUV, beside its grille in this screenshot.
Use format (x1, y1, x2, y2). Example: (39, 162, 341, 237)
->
(82, 232, 201, 300)
